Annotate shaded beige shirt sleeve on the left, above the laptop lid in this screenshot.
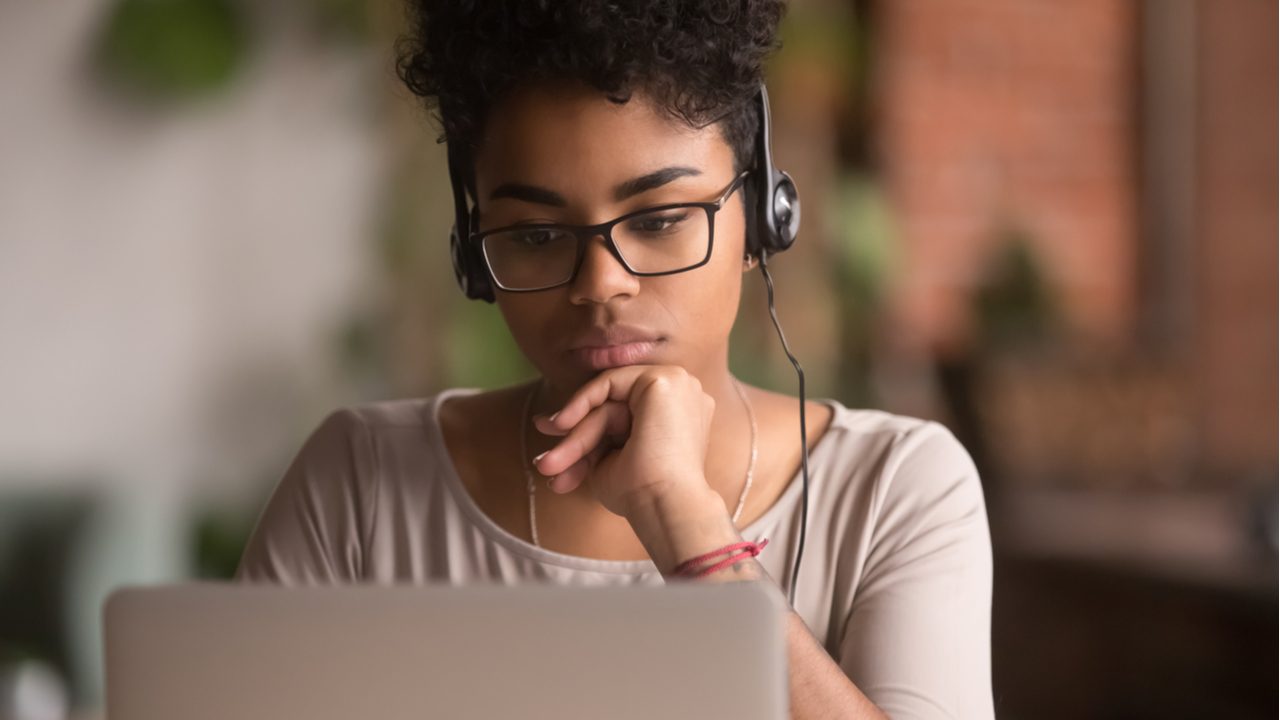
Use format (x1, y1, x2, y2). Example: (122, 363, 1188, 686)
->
(236, 410, 378, 585)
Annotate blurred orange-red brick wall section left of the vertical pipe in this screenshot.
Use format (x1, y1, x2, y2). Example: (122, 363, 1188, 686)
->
(876, 0, 1137, 351)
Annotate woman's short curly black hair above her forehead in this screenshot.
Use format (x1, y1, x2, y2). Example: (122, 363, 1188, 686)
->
(397, 0, 783, 172)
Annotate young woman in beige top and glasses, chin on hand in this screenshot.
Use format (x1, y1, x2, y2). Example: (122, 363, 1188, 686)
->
(239, 0, 993, 720)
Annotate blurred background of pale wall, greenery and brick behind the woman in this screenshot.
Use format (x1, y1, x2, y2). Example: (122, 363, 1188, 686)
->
(0, 0, 1280, 720)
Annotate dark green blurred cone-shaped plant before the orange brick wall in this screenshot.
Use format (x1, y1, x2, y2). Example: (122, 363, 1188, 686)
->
(973, 231, 1059, 351)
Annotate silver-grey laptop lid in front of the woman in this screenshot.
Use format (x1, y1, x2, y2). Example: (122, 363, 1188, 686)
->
(105, 583, 787, 720)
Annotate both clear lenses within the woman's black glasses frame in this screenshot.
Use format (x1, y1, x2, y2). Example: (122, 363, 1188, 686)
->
(481, 208, 710, 290)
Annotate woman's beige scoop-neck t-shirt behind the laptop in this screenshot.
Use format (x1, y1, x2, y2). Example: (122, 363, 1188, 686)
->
(238, 389, 995, 720)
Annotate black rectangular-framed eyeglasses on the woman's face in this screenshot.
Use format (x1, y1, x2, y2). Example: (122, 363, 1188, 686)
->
(471, 173, 749, 292)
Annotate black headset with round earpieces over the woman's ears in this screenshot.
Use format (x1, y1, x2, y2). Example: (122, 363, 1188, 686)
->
(448, 83, 800, 302)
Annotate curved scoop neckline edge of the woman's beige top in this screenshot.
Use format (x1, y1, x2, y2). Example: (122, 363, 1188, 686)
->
(424, 388, 842, 575)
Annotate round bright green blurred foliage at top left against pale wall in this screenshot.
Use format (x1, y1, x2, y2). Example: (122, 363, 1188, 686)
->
(99, 0, 250, 97)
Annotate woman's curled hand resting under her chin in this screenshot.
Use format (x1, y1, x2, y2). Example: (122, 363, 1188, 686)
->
(535, 365, 723, 519)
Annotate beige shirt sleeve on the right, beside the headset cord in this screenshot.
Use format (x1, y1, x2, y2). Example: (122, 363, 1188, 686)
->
(840, 423, 995, 720)
